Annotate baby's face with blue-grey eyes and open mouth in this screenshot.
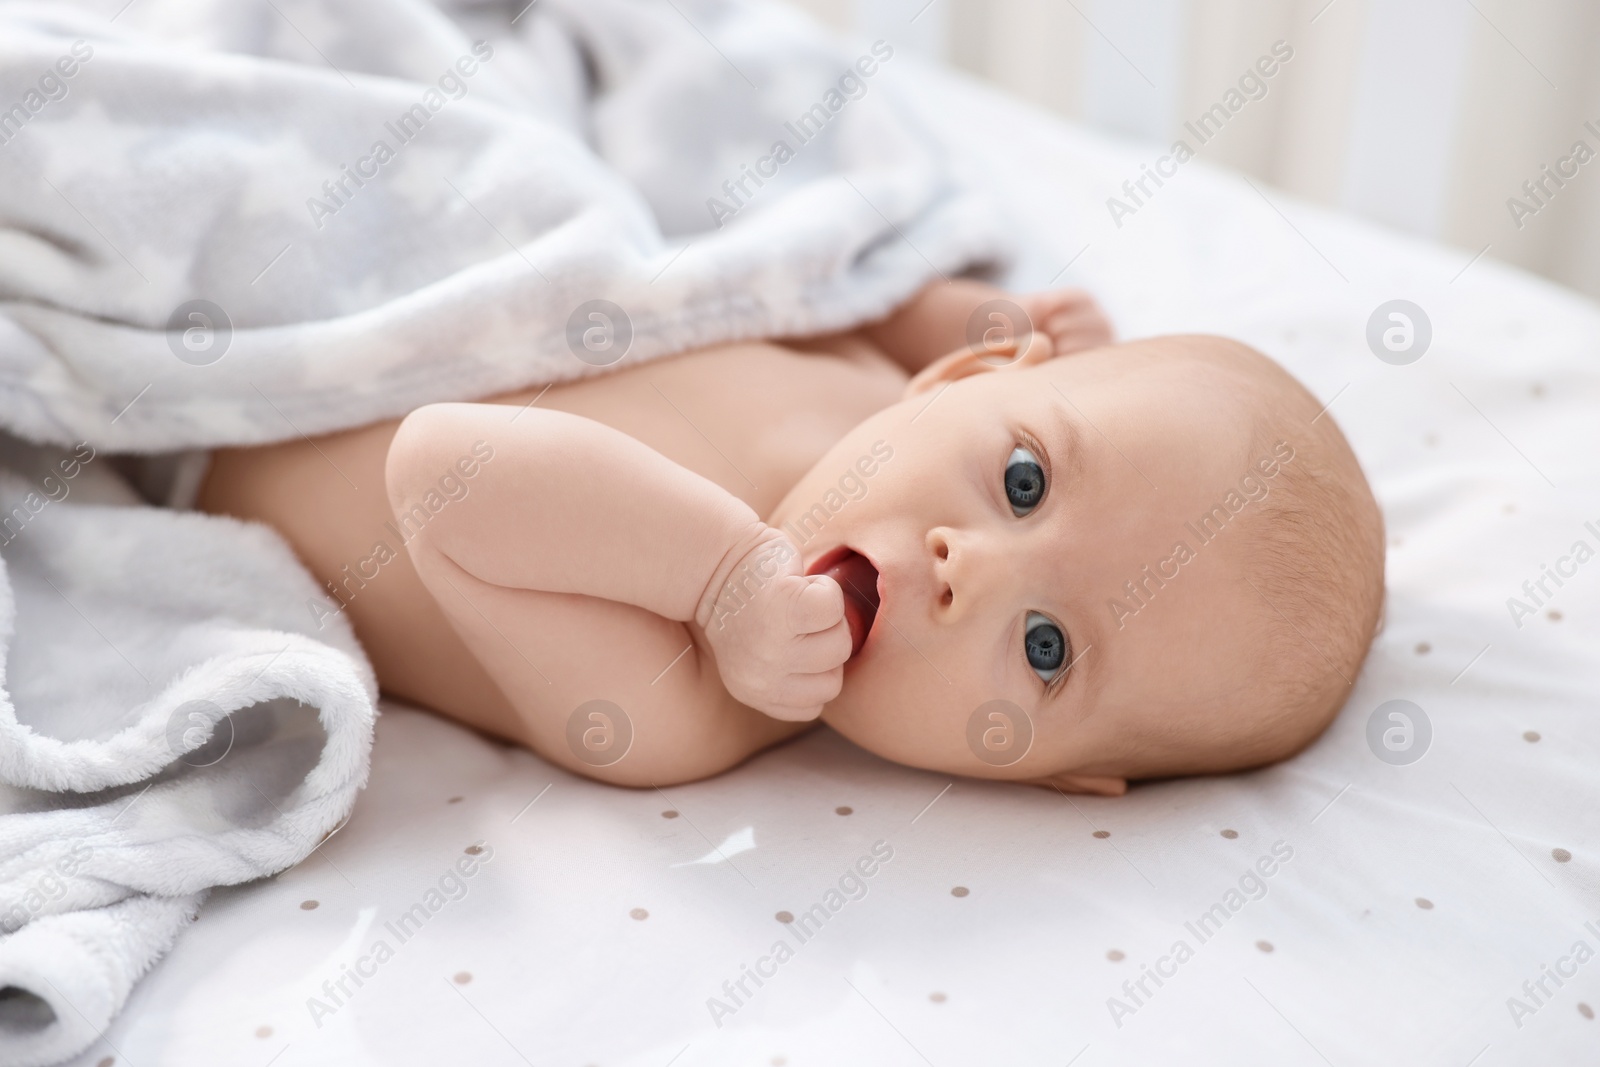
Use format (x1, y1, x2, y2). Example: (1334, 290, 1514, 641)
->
(770, 341, 1270, 792)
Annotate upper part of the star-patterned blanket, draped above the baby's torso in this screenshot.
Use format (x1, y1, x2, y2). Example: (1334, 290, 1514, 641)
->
(0, 0, 1002, 451)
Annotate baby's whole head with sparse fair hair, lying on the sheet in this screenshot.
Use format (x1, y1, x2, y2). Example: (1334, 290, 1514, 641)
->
(771, 336, 1384, 793)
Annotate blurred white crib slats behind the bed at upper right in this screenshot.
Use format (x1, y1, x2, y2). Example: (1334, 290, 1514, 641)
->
(795, 0, 1600, 296)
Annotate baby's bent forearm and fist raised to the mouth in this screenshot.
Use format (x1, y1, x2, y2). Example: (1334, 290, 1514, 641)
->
(387, 403, 850, 720)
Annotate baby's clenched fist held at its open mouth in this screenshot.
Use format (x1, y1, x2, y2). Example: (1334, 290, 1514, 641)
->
(696, 528, 850, 721)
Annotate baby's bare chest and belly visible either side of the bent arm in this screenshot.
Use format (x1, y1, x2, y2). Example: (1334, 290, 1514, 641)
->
(200, 337, 904, 737)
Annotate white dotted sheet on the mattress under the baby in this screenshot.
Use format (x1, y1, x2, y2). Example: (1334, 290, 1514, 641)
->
(78, 54, 1600, 1067)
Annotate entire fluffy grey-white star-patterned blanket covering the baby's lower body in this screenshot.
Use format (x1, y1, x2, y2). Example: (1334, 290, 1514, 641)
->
(0, 0, 1002, 1067)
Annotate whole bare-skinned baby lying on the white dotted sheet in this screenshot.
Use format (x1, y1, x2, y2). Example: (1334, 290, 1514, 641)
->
(200, 280, 1384, 795)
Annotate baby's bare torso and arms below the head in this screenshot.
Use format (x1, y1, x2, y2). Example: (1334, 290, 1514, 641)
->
(200, 282, 1109, 785)
